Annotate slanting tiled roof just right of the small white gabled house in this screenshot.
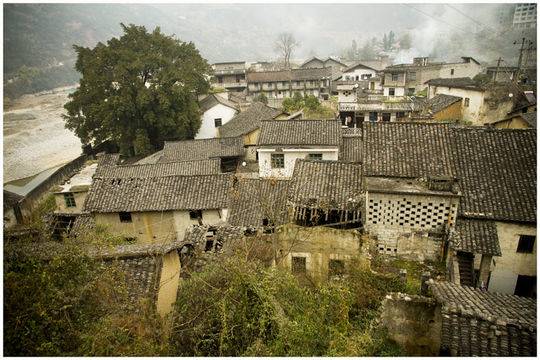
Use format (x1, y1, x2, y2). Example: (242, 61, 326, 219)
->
(219, 102, 281, 137)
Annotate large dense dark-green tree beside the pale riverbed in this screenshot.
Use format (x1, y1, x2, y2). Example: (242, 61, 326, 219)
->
(65, 24, 211, 155)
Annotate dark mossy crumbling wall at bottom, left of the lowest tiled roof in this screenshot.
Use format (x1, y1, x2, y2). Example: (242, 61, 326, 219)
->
(381, 293, 442, 356)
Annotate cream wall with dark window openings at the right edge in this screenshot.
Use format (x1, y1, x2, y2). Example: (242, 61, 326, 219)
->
(488, 222, 537, 294)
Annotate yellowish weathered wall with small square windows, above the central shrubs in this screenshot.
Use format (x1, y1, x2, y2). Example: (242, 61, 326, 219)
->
(276, 224, 368, 282)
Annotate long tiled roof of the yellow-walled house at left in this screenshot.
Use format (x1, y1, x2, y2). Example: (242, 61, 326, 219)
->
(84, 174, 230, 212)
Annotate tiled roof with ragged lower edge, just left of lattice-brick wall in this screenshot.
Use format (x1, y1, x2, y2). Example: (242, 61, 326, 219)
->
(289, 160, 363, 210)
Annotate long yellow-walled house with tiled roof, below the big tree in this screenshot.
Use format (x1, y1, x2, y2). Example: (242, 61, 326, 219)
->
(84, 172, 231, 243)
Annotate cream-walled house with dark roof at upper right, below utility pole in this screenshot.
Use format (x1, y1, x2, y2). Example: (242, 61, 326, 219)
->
(426, 77, 528, 125)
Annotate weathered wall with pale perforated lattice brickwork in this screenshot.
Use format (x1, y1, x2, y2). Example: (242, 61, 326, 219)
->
(364, 192, 458, 260)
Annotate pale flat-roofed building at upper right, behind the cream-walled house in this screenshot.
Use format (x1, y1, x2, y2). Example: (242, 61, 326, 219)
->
(383, 57, 482, 96)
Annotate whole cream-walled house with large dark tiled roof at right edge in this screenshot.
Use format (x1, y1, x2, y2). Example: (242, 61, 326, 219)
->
(452, 127, 537, 296)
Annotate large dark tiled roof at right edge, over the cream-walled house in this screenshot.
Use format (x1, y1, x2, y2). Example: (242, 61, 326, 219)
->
(452, 127, 536, 222)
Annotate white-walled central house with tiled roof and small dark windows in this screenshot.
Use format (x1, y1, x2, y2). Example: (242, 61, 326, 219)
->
(257, 120, 342, 179)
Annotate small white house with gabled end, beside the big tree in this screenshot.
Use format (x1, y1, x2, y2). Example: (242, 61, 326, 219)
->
(195, 94, 238, 139)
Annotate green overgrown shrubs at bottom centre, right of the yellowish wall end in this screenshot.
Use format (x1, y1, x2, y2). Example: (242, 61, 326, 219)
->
(170, 258, 403, 356)
